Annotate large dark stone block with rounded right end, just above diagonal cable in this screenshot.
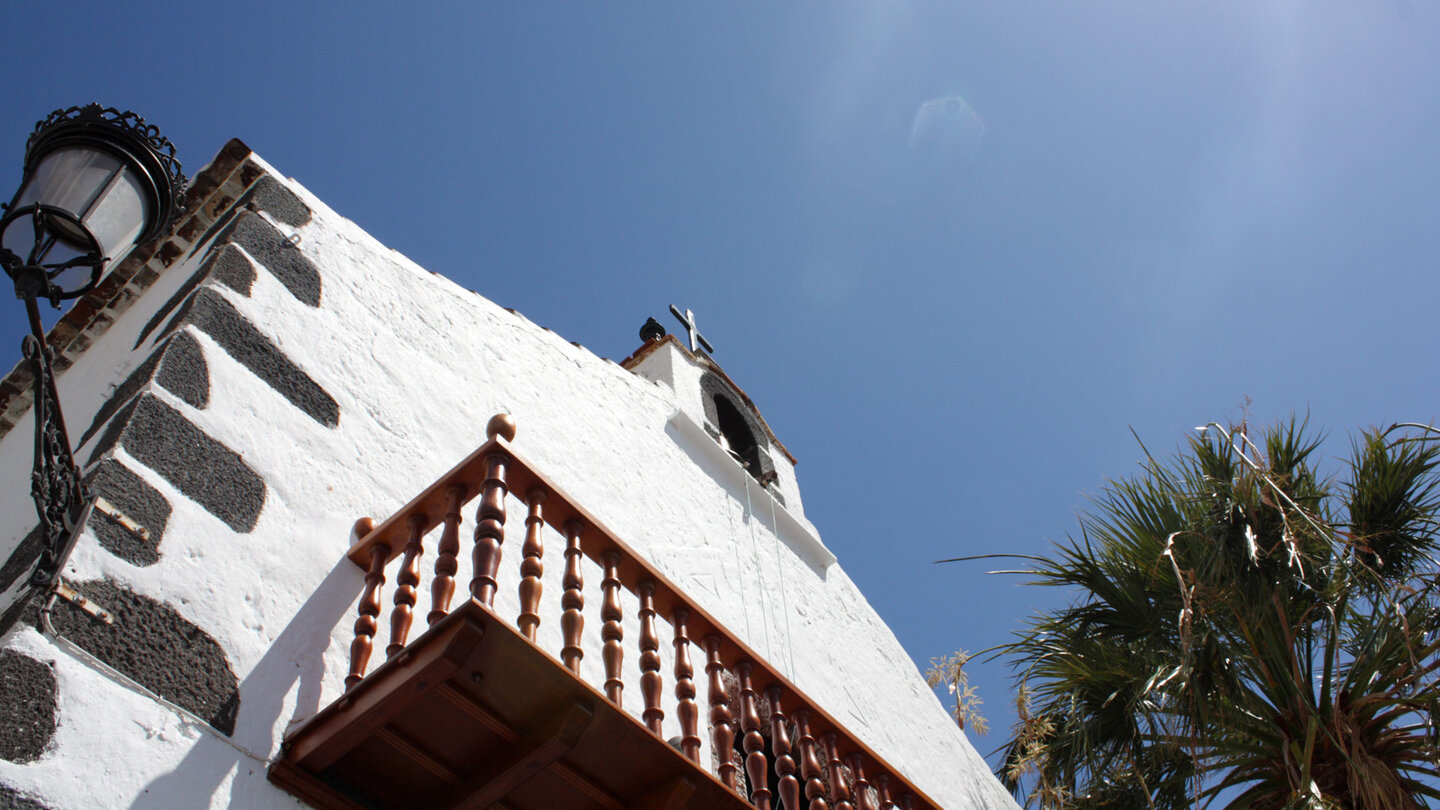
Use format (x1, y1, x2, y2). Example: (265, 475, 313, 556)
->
(38, 579, 240, 734)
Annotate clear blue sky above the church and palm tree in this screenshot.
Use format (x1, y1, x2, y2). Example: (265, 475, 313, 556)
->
(0, 0, 1440, 778)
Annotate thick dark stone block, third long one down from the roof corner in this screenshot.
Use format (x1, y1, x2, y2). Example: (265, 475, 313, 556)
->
(91, 393, 265, 532)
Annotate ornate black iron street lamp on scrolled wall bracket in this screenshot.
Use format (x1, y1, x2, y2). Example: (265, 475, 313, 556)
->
(0, 104, 186, 589)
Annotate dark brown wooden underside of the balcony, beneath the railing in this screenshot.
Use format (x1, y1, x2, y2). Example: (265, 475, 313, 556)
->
(269, 601, 750, 810)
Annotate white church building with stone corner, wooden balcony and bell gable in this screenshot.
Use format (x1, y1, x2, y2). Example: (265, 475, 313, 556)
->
(0, 135, 1015, 810)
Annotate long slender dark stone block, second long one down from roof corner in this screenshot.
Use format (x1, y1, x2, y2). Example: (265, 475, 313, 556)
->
(166, 288, 340, 428)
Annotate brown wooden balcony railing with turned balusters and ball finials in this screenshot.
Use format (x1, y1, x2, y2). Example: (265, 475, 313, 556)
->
(346, 414, 939, 810)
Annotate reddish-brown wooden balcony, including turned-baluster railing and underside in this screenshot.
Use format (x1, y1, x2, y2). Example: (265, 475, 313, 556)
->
(269, 417, 936, 810)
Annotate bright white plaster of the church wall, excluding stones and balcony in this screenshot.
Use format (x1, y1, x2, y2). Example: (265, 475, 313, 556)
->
(0, 152, 1014, 810)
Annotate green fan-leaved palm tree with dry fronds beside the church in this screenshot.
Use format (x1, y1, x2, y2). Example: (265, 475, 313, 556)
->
(998, 419, 1440, 810)
